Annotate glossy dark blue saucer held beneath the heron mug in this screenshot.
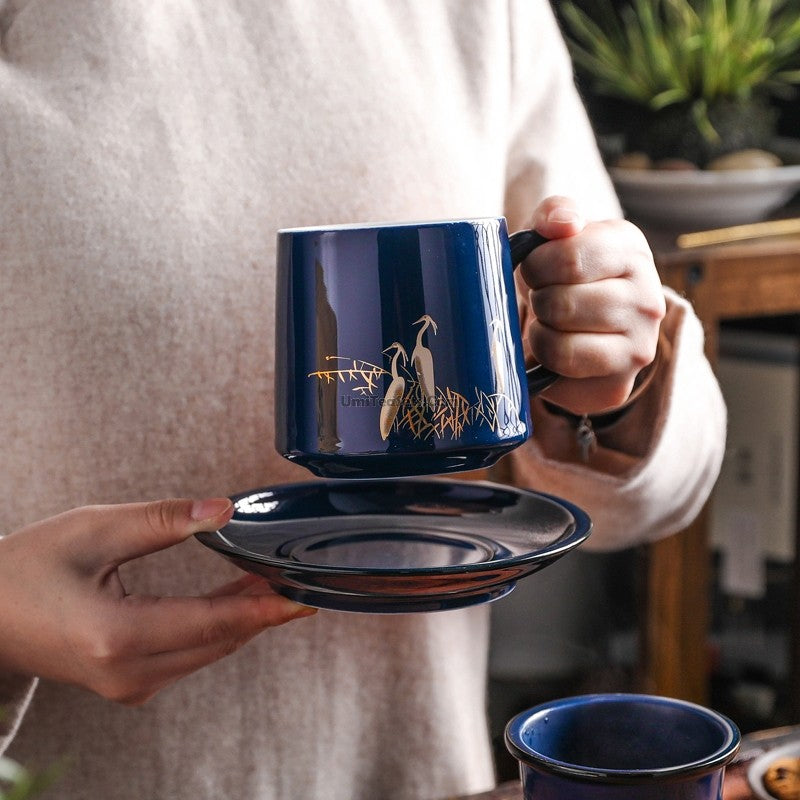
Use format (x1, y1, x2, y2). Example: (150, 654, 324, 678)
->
(197, 479, 591, 613)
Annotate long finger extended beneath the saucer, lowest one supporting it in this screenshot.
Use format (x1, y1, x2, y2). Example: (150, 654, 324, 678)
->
(120, 592, 316, 655)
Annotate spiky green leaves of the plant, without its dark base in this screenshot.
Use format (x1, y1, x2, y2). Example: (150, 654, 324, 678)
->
(560, 0, 800, 162)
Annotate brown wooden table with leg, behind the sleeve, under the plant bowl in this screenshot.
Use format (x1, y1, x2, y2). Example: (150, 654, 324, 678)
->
(641, 234, 800, 708)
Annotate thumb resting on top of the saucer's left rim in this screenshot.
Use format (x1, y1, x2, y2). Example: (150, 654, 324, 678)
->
(69, 497, 233, 569)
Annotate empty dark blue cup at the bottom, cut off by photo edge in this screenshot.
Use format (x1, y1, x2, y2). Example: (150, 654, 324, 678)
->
(505, 694, 741, 800)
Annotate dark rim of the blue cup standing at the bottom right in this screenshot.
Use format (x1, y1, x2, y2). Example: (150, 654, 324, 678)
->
(505, 692, 741, 784)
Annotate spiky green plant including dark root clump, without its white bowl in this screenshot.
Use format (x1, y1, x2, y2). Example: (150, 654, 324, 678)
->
(560, 0, 800, 168)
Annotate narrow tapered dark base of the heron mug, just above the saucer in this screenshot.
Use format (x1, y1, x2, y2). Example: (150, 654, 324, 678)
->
(283, 439, 524, 479)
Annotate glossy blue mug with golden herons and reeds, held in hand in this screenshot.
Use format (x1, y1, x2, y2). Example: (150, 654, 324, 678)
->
(275, 218, 557, 478)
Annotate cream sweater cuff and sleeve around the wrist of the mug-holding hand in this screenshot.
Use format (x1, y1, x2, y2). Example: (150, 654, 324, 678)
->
(498, 289, 727, 550)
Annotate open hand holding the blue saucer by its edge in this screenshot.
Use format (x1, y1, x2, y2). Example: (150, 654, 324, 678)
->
(0, 498, 314, 705)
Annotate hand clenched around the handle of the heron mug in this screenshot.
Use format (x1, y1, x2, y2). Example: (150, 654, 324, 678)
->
(520, 196, 666, 414)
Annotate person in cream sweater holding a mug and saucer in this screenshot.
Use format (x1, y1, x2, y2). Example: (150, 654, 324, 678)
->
(0, 0, 725, 800)
